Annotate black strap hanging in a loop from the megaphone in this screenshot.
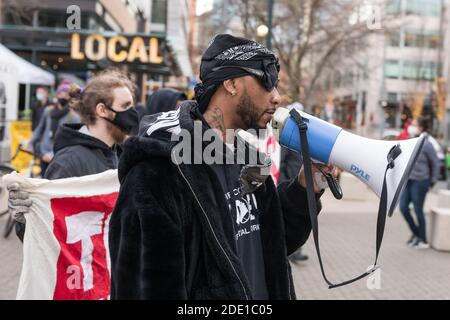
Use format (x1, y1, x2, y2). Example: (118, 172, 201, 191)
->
(290, 109, 402, 289)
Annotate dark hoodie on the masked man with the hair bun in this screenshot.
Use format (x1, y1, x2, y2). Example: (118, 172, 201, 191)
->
(44, 124, 118, 180)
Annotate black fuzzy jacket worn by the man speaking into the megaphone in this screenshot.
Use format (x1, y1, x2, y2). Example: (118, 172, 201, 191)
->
(109, 102, 320, 299)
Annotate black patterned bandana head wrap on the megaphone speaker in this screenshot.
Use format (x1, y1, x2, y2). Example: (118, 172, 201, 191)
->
(195, 34, 280, 113)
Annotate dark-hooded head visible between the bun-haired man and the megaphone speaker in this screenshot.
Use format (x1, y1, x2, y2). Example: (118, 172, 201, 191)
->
(147, 88, 187, 115)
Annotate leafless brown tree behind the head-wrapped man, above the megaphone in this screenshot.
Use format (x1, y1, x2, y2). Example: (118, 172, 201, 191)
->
(221, 0, 396, 104)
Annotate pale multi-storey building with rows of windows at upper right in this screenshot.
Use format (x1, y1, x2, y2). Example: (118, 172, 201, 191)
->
(316, 0, 448, 135)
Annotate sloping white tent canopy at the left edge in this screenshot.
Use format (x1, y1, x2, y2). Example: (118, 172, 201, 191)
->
(0, 43, 55, 86)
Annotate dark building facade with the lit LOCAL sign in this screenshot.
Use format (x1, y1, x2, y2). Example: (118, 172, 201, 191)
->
(0, 0, 192, 109)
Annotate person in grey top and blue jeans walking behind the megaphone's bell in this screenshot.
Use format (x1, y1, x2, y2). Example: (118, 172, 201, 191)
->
(400, 118, 440, 249)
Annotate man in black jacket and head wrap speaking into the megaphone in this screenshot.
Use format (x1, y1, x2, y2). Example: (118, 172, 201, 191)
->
(109, 35, 332, 300)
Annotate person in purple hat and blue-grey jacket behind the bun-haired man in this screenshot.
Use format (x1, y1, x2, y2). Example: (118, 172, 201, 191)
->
(28, 82, 80, 176)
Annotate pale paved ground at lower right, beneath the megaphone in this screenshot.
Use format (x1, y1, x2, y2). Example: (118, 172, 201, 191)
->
(292, 186, 450, 299)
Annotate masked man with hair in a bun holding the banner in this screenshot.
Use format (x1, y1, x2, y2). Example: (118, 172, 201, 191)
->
(8, 71, 138, 240)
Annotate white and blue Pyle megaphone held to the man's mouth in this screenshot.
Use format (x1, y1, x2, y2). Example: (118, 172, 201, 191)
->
(272, 108, 425, 216)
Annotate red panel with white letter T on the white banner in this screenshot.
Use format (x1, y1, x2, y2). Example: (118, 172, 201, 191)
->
(50, 192, 118, 300)
